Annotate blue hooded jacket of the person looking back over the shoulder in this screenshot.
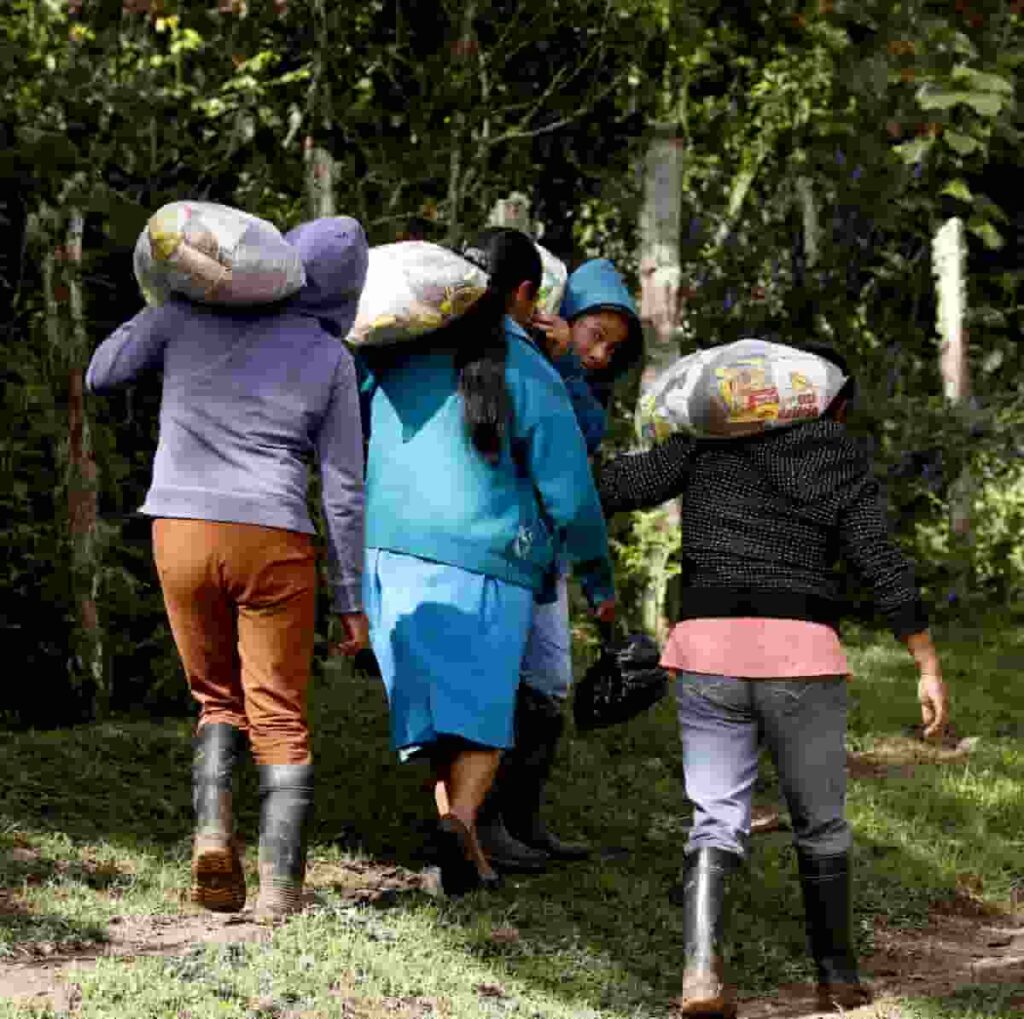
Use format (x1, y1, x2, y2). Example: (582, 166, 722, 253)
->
(553, 258, 640, 453)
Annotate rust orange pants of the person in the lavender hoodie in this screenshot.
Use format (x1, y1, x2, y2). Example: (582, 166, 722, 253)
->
(153, 518, 316, 764)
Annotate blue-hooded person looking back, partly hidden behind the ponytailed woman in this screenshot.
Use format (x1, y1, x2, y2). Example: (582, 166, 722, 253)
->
(478, 250, 643, 873)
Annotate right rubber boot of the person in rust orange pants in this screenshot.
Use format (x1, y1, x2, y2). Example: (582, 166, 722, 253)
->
(256, 764, 313, 922)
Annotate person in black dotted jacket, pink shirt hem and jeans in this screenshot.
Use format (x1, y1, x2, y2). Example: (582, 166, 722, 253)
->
(597, 346, 948, 1017)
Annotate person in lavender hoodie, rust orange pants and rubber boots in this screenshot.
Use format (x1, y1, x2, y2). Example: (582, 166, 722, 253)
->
(86, 217, 368, 921)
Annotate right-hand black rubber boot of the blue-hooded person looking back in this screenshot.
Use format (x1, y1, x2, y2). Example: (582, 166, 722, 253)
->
(501, 683, 590, 860)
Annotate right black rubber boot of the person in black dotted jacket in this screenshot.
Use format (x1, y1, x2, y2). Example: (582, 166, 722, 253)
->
(797, 850, 871, 1010)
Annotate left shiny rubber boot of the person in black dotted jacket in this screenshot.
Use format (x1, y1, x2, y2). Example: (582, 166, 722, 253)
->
(679, 847, 740, 1019)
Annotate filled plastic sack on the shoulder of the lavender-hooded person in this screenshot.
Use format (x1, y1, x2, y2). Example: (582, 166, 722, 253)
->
(135, 202, 306, 306)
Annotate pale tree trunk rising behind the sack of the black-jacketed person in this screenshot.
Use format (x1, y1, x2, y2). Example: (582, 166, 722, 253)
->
(638, 129, 683, 636)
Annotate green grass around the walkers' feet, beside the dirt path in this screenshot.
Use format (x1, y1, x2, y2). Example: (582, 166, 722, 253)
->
(0, 625, 1024, 1019)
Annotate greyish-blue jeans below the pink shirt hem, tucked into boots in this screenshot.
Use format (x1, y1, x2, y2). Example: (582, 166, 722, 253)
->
(676, 672, 852, 856)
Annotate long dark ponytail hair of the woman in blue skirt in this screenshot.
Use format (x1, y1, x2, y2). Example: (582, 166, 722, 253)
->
(447, 227, 542, 464)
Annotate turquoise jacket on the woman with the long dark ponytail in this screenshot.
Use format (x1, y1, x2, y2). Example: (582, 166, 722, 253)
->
(362, 320, 614, 605)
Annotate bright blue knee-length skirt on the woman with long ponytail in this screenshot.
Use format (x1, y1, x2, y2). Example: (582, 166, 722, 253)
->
(362, 548, 534, 757)
